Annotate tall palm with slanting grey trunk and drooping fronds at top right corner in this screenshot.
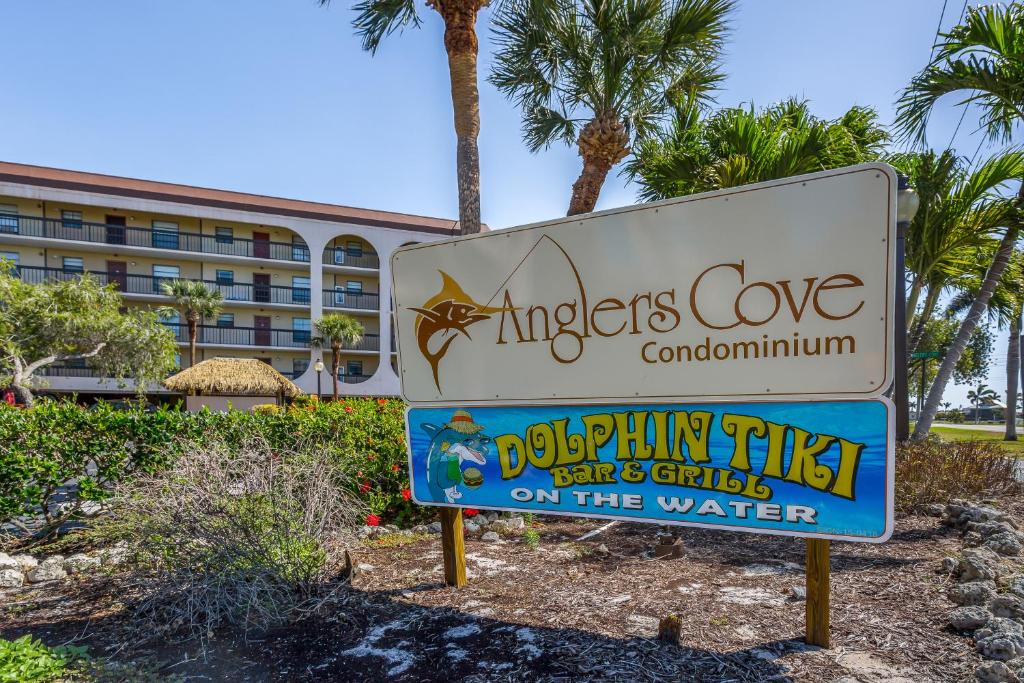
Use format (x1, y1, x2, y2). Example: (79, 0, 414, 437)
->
(896, 2, 1024, 440)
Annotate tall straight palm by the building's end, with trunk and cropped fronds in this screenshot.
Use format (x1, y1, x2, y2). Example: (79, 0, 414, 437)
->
(317, 0, 487, 234)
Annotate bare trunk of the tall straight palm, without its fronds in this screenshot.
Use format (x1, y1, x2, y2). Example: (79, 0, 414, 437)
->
(437, 5, 480, 234)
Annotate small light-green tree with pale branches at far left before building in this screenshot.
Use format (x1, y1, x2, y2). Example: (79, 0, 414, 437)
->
(0, 262, 176, 405)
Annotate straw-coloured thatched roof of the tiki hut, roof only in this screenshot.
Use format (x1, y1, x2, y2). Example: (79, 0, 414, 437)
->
(164, 357, 302, 398)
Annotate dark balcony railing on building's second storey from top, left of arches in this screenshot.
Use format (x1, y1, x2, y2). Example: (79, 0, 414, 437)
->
(17, 265, 310, 307)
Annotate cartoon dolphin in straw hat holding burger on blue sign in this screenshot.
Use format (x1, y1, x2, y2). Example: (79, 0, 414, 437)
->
(423, 411, 492, 503)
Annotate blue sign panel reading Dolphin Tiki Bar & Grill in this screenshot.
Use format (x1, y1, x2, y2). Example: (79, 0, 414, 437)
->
(406, 399, 894, 543)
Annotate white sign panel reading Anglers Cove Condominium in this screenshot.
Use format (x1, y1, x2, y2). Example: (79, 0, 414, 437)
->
(392, 164, 896, 403)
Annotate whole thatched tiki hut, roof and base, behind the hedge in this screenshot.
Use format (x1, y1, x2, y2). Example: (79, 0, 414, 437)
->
(164, 358, 302, 411)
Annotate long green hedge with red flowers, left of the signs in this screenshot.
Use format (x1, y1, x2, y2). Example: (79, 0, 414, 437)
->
(0, 398, 423, 523)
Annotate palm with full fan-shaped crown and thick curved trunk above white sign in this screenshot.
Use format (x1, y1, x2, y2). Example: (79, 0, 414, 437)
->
(489, 0, 733, 216)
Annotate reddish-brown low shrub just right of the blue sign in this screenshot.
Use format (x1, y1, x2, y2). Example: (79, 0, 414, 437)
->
(896, 436, 1021, 510)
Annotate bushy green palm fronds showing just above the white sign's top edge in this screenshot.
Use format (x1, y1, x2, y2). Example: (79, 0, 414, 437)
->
(627, 98, 888, 201)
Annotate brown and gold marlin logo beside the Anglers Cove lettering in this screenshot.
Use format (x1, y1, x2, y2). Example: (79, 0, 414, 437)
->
(410, 270, 505, 391)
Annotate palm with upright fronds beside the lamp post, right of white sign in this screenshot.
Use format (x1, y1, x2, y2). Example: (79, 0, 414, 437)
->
(887, 150, 1024, 353)
